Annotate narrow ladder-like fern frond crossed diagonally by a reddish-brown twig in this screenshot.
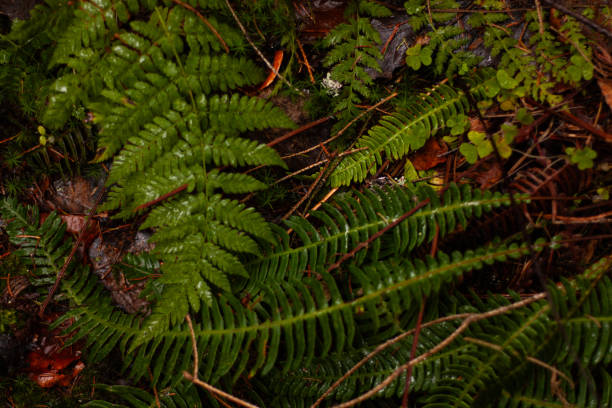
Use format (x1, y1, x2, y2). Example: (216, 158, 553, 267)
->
(246, 184, 525, 292)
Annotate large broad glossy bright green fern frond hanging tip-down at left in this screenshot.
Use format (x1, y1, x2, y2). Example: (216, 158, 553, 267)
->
(41, 0, 294, 323)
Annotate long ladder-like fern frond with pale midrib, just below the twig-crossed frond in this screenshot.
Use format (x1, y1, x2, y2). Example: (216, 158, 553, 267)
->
(135, 237, 540, 382)
